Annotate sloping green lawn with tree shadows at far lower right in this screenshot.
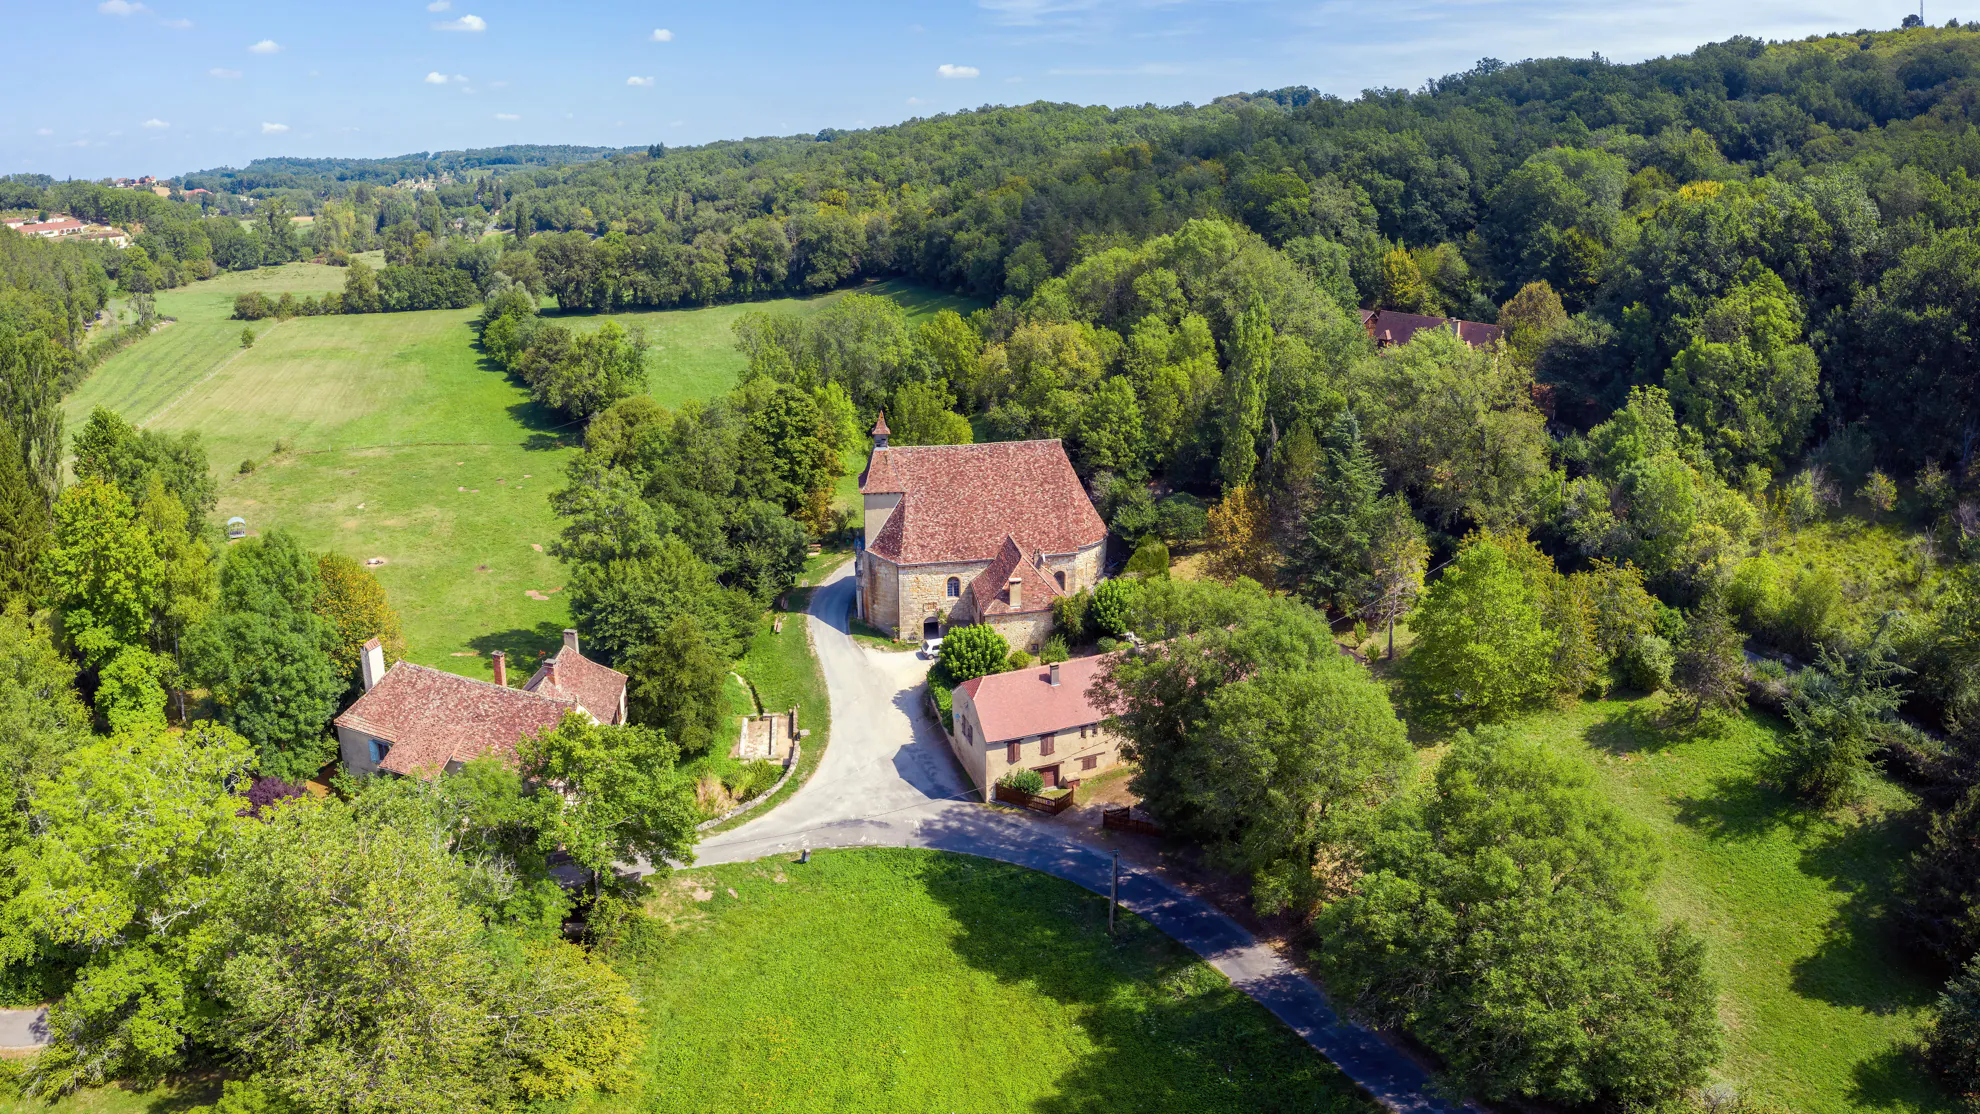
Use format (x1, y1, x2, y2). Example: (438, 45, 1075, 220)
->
(1513, 698, 1952, 1114)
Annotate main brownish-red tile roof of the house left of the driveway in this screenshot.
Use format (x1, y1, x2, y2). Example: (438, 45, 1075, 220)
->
(337, 661, 574, 776)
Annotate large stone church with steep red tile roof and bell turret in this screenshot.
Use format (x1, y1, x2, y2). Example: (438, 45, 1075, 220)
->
(853, 414, 1107, 651)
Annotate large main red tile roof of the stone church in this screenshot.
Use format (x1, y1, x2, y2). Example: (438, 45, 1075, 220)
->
(859, 441, 1107, 564)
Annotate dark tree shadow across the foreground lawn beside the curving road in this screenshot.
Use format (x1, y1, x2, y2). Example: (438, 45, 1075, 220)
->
(921, 855, 1372, 1114)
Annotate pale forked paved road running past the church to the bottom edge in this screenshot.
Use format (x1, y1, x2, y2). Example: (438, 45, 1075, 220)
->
(695, 566, 1471, 1114)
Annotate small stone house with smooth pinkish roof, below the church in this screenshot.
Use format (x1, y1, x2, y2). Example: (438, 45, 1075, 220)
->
(948, 655, 1121, 801)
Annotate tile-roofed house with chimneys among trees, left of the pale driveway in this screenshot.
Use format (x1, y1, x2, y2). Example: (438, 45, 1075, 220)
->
(335, 631, 626, 778)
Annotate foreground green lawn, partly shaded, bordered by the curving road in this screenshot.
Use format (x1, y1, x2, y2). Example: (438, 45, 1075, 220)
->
(578, 849, 1376, 1114)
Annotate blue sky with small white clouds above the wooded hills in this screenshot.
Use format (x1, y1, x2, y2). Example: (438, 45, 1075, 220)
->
(0, 0, 1948, 178)
